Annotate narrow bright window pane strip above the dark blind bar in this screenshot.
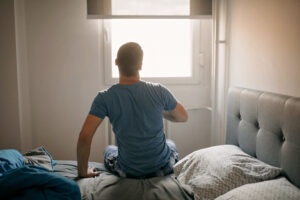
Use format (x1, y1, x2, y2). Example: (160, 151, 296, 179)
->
(112, 0, 190, 15)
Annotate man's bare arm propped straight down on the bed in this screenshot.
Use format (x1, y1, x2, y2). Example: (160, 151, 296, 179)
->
(77, 114, 103, 177)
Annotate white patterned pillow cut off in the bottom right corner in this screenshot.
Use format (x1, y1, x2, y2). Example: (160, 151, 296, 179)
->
(216, 177, 300, 200)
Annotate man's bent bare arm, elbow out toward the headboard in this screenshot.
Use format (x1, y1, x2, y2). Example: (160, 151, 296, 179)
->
(163, 102, 188, 122)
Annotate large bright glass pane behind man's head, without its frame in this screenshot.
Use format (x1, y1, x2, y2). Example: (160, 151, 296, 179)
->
(111, 19, 192, 78)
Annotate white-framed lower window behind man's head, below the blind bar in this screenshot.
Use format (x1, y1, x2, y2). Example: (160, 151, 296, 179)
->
(104, 19, 202, 84)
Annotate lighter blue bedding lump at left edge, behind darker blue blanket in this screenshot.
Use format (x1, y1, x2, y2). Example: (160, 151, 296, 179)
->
(0, 149, 25, 175)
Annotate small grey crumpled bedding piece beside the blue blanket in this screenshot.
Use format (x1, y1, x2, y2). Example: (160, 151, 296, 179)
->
(23, 146, 56, 171)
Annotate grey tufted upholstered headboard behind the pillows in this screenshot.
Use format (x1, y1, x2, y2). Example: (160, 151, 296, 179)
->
(226, 88, 300, 187)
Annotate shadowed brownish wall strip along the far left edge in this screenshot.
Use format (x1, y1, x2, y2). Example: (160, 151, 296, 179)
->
(0, 0, 21, 150)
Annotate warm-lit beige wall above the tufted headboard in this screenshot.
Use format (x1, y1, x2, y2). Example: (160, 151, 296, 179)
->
(228, 0, 300, 97)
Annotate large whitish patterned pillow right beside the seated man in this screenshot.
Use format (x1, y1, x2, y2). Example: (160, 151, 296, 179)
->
(174, 145, 281, 200)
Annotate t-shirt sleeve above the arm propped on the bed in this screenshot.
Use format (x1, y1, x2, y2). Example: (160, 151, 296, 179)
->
(89, 92, 107, 119)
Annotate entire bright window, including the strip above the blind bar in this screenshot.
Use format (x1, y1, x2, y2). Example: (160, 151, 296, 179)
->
(102, 0, 203, 84)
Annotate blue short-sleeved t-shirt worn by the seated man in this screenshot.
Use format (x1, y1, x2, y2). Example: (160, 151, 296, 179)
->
(90, 81, 177, 176)
